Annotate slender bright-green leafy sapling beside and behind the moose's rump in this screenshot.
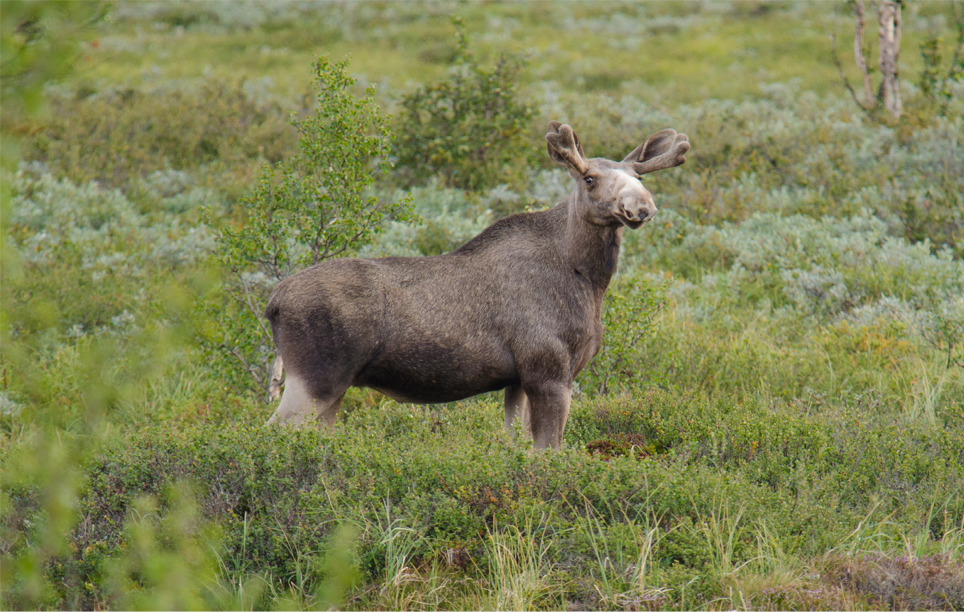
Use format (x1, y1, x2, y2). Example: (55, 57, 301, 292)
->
(201, 58, 410, 391)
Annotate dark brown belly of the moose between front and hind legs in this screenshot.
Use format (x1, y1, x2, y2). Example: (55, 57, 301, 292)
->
(355, 343, 519, 404)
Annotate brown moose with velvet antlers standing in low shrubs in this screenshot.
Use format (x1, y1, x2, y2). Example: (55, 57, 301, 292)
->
(265, 121, 690, 449)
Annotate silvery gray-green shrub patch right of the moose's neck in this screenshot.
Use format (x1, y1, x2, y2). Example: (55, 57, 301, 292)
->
(620, 210, 964, 350)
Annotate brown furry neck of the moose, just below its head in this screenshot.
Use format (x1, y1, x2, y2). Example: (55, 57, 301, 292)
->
(563, 192, 623, 300)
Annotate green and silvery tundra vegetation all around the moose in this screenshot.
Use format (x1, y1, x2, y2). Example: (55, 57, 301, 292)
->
(0, 1, 964, 610)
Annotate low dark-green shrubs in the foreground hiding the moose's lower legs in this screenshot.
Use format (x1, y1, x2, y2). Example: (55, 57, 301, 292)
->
(5, 391, 964, 608)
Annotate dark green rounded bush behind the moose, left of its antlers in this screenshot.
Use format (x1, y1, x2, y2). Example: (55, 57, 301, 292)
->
(395, 20, 533, 190)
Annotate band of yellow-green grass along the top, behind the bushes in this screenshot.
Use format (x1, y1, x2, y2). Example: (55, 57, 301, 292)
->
(74, 2, 953, 105)
